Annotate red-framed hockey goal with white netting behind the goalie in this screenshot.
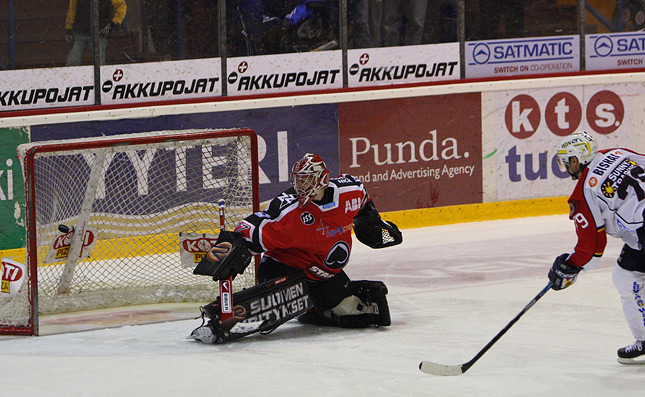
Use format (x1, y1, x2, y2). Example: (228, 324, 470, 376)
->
(0, 129, 259, 335)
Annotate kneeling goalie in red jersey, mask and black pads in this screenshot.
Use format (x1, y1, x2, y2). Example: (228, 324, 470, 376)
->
(192, 153, 403, 343)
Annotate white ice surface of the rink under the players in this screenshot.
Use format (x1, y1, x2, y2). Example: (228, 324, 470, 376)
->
(0, 215, 645, 397)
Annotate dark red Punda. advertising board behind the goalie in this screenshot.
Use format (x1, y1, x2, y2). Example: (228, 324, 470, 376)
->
(339, 93, 482, 211)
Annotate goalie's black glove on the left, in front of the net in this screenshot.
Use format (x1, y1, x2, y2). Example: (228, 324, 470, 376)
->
(193, 231, 251, 281)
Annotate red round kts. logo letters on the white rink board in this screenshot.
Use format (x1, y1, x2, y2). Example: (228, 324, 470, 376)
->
(504, 90, 625, 139)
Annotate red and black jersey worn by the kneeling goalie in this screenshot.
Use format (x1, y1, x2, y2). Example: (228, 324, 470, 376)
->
(235, 175, 370, 280)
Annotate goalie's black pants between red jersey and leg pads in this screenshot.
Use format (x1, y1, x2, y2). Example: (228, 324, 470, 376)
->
(257, 255, 353, 312)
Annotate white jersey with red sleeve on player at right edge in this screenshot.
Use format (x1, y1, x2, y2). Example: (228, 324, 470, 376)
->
(567, 149, 645, 268)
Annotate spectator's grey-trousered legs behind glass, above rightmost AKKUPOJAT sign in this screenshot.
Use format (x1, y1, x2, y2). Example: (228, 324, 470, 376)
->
(381, 0, 428, 47)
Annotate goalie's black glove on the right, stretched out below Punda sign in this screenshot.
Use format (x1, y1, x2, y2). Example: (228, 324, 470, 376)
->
(354, 201, 403, 248)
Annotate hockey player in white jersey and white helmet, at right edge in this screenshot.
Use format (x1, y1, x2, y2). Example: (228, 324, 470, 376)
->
(549, 132, 645, 364)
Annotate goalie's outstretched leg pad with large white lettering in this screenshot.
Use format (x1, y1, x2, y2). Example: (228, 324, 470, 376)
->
(195, 271, 313, 343)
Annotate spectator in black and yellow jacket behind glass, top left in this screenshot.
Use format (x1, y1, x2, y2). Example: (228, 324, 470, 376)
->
(65, 0, 127, 66)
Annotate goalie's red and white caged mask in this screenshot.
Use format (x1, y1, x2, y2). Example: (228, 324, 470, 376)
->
(291, 153, 329, 207)
